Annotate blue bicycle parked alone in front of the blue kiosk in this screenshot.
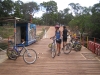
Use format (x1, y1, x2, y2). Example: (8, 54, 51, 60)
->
(7, 41, 37, 64)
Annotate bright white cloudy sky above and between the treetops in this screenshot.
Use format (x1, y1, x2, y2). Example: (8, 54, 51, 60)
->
(13, 0, 99, 17)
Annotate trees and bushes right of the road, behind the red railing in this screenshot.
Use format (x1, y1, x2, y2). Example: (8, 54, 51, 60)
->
(69, 3, 100, 38)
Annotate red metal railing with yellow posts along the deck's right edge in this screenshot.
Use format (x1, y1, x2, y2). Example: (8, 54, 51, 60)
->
(81, 36, 100, 56)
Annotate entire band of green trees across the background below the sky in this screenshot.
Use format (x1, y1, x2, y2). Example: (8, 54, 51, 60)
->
(0, 0, 100, 38)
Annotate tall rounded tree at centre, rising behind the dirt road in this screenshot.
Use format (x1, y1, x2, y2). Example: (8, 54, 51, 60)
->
(40, 1, 57, 25)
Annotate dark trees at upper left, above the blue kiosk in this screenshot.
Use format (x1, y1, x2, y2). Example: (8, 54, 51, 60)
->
(0, 0, 39, 21)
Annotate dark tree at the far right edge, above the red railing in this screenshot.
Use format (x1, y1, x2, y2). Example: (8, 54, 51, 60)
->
(91, 3, 100, 38)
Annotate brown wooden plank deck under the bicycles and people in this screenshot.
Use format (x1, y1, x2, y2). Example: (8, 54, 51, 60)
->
(0, 27, 100, 75)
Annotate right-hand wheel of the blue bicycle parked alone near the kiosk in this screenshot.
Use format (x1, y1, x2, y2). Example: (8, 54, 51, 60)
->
(23, 49, 37, 64)
